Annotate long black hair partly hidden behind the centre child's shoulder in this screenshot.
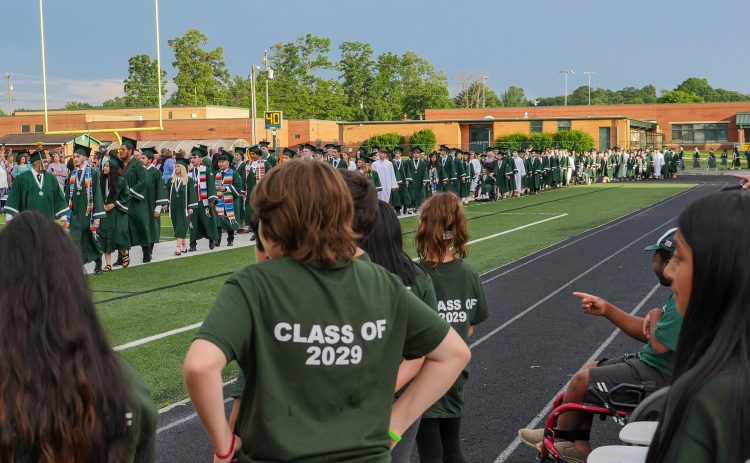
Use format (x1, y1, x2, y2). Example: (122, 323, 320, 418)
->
(360, 200, 416, 286)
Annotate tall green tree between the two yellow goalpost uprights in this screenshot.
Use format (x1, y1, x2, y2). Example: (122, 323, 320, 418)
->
(123, 55, 167, 108)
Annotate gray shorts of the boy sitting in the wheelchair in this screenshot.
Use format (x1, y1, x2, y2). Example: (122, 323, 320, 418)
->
(584, 354, 672, 405)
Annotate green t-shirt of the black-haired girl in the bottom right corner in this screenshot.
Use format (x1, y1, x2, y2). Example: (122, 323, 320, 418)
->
(663, 363, 750, 463)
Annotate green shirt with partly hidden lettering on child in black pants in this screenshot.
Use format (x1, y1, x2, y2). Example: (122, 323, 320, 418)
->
(420, 260, 490, 418)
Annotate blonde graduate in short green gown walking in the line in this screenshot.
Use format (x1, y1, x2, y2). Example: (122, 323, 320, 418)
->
(167, 158, 198, 256)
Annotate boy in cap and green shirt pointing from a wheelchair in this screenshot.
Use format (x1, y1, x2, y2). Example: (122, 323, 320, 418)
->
(518, 228, 682, 463)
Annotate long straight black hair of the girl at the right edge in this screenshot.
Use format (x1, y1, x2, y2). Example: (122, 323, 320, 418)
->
(647, 191, 750, 462)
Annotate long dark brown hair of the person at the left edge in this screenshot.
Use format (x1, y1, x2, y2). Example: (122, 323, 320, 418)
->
(0, 212, 131, 463)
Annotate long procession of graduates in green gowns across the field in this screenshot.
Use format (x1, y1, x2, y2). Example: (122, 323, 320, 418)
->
(4, 137, 704, 274)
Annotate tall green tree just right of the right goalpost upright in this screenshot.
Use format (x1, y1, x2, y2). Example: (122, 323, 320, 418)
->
(167, 29, 229, 106)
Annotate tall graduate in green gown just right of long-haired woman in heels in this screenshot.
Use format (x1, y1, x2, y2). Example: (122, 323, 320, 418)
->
(115, 137, 153, 265)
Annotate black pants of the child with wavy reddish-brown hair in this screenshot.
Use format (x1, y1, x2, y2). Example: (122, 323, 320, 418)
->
(417, 418, 466, 463)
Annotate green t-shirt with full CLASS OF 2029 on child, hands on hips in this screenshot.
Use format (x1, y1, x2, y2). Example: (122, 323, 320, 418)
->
(197, 257, 449, 462)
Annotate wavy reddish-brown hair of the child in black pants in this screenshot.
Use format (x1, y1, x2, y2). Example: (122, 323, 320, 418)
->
(415, 193, 469, 268)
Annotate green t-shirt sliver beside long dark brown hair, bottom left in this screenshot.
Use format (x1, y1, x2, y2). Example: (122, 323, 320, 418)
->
(116, 354, 159, 463)
